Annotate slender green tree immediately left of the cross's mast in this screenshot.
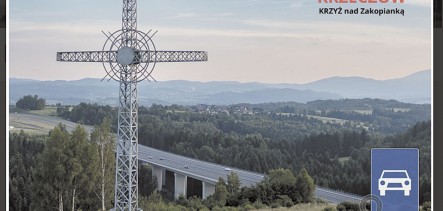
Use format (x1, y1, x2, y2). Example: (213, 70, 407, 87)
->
(91, 118, 115, 210)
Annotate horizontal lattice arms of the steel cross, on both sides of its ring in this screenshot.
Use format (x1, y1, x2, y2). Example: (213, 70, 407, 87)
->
(57, 51, 208, 63)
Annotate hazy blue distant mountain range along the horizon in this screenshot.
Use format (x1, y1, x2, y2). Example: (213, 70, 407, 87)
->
(9, 70, 431, 105)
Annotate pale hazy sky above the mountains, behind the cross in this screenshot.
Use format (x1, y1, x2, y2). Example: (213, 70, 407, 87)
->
(9, 0, 432, 84)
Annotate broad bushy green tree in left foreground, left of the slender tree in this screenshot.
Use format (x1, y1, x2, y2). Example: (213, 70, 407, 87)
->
(31, 125, 98, 211)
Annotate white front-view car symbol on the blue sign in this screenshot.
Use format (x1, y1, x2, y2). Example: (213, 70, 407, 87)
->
(378, 170, 411, 196)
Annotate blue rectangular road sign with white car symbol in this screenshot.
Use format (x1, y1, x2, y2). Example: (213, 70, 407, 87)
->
(371, 148, 419, 211)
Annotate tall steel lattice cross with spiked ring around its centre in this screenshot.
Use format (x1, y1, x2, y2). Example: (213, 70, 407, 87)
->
(57, 0, 208, 211)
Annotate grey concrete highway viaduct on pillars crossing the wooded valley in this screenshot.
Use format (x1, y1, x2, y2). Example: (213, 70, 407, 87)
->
(138, 145, 362, 204)
